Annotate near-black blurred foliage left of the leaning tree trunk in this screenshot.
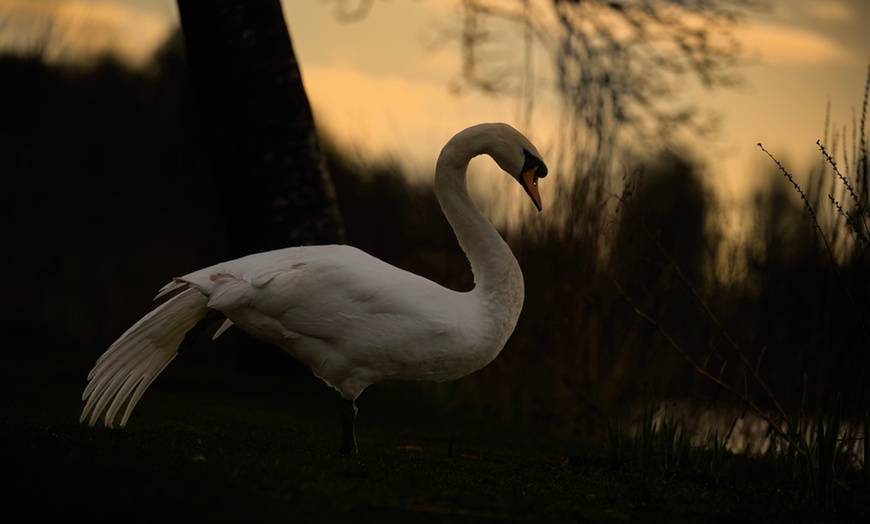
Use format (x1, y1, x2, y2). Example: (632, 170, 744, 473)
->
(0, 42, 224, 347)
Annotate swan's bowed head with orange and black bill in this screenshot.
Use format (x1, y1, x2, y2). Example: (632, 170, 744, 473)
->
(481, 124, 547, 211)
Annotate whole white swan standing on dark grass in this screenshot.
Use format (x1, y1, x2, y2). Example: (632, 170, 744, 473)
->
(79, 123, 547, 454)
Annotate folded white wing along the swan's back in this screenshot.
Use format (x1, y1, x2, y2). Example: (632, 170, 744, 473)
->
(174, 246, 466, 342)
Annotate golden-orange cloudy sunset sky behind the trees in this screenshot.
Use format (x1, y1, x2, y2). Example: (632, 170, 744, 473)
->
(0, 0, 870, 215)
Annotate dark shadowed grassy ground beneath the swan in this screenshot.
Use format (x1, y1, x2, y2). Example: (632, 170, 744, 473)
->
(0, 346, 870, 522)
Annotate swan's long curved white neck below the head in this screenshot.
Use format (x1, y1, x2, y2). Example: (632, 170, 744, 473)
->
(435, 138, 523, 314)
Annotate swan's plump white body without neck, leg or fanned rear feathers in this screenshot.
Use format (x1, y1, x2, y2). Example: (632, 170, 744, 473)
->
(149, 246, 488, 392)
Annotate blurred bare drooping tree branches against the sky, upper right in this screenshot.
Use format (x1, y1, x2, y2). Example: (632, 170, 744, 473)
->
(461, 0, 766, 163)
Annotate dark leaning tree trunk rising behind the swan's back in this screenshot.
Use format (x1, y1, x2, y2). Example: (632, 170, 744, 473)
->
(178, 0, 344, 256)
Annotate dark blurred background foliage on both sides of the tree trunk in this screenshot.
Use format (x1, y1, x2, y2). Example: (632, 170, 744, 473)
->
(0, 33, 870, 446)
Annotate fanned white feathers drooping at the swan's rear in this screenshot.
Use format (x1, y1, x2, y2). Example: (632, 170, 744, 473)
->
(79, 286, 208, 428)
